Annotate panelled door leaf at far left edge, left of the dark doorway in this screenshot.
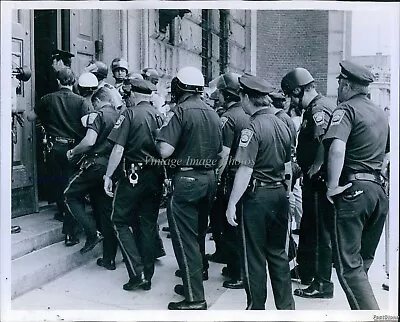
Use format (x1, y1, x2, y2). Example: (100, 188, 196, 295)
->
(10, 10, 38, 217)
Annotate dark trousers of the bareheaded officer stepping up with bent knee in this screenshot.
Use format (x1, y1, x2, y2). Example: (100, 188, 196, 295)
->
(64, 163, 118, 261)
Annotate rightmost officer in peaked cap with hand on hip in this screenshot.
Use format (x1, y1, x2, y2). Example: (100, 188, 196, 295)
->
(324, 61, 389, 310)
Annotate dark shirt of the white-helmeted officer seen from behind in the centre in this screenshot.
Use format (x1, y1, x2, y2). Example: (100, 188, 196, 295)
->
(157, 95, 222, 169)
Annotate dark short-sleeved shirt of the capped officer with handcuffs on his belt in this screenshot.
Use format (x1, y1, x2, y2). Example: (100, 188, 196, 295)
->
(108, 102, 162, 164)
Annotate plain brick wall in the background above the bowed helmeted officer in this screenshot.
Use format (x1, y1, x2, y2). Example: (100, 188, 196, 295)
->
(257, 10, 329, 95)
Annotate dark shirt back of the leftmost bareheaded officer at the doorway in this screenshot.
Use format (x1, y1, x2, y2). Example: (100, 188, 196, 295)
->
(35, 88, 91, 141)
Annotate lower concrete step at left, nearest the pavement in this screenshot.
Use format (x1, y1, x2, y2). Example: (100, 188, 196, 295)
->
(11, 238, 102, 299)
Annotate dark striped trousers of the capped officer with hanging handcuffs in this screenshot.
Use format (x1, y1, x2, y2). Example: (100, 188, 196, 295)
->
(111, 168, 163, 281)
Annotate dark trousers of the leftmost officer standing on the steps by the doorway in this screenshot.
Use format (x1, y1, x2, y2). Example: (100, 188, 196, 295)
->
(47, 142, 79, 235)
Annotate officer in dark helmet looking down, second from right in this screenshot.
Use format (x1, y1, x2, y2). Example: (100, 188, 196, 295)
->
(281, 68, 335, 298)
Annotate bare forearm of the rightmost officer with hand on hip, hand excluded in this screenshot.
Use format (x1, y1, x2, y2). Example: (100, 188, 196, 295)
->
(327, 139, 346, 189)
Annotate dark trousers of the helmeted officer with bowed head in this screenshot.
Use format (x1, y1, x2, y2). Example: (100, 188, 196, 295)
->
(297, 178, 333, 292)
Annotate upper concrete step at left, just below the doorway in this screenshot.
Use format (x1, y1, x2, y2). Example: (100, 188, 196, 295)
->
(11, 206, 64, 260)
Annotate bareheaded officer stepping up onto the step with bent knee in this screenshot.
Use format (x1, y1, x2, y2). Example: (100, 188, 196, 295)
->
(64, 87, 119, 269)
